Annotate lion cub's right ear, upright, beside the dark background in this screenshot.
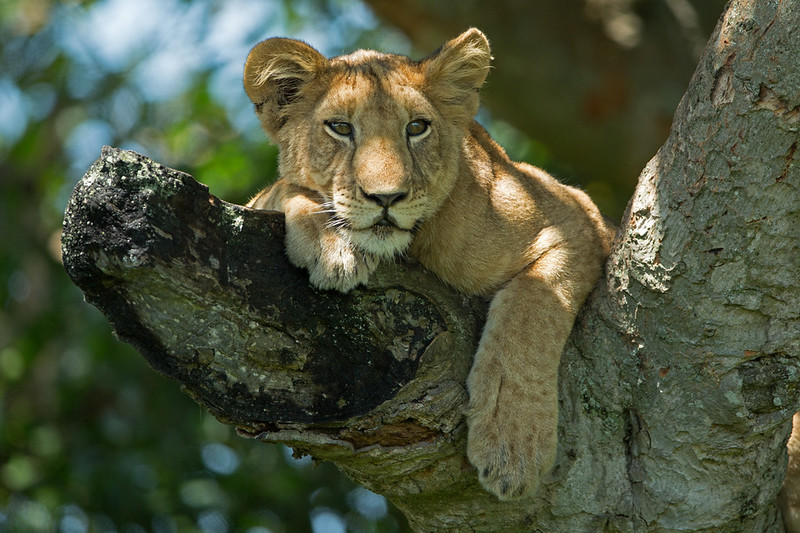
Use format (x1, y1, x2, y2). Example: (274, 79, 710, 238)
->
(421, 28, 492, 119)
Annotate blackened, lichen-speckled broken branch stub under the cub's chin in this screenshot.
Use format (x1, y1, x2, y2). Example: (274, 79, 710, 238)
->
(63, 148, 480, 431)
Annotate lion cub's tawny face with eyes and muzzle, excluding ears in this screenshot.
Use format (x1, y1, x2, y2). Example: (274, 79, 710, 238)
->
(288, 55, 460, 256)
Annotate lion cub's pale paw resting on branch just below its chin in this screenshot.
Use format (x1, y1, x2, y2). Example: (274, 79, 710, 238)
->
(308, 233, 378, 292)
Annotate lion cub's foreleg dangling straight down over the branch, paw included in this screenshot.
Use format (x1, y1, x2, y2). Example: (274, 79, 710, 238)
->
(467, 245, 598, 500)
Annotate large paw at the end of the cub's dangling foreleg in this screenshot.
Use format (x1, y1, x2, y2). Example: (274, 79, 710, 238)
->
(467, 368, 558, 500)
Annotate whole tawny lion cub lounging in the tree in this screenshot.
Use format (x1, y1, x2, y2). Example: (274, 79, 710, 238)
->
(244, 29, 613, 499)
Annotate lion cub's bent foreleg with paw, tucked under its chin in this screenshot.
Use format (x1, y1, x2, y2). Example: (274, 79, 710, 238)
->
(247, 180, 378, 292)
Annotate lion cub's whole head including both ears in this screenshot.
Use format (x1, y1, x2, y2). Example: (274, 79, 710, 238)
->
(244, 29, 491, 257)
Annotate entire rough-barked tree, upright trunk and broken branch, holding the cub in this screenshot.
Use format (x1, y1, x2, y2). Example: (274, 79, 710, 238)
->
(63, 0, 800, 532)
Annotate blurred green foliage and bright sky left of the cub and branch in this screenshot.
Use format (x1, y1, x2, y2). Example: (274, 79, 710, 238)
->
(0, 0, 407, 533)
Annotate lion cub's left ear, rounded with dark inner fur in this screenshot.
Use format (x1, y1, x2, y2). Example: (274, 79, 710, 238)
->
(244, 37, 328, 135)
